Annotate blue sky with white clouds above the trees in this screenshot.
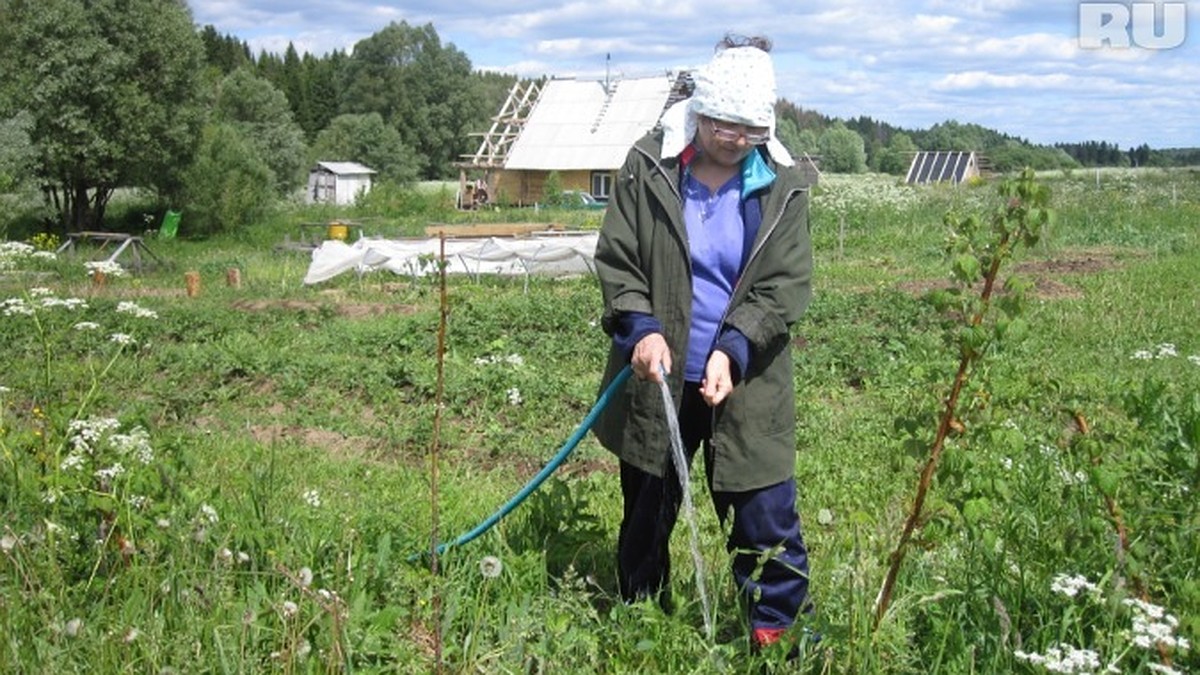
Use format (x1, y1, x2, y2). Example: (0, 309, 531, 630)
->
(188, 0, 1200, 148)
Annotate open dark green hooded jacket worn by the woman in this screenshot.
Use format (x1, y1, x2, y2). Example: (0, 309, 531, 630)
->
(594, 132, 812, 491)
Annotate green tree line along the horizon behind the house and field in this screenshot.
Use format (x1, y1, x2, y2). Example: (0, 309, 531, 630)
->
(0, 0, 1195, 232)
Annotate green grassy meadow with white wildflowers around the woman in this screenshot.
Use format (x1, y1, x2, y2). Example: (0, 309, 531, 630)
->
(0, 169, 1200, 673)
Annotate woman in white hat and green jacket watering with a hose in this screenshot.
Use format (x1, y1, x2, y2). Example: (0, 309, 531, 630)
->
(595, 37, 812, 647)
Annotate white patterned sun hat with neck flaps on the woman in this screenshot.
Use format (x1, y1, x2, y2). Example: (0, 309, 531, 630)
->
(661, 47, 796, 167)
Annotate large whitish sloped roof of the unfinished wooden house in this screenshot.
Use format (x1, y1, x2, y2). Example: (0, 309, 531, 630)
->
(504, 74, 674, 171)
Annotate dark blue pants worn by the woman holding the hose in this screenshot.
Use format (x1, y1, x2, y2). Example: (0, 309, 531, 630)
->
(617, 382, 810, 628)
